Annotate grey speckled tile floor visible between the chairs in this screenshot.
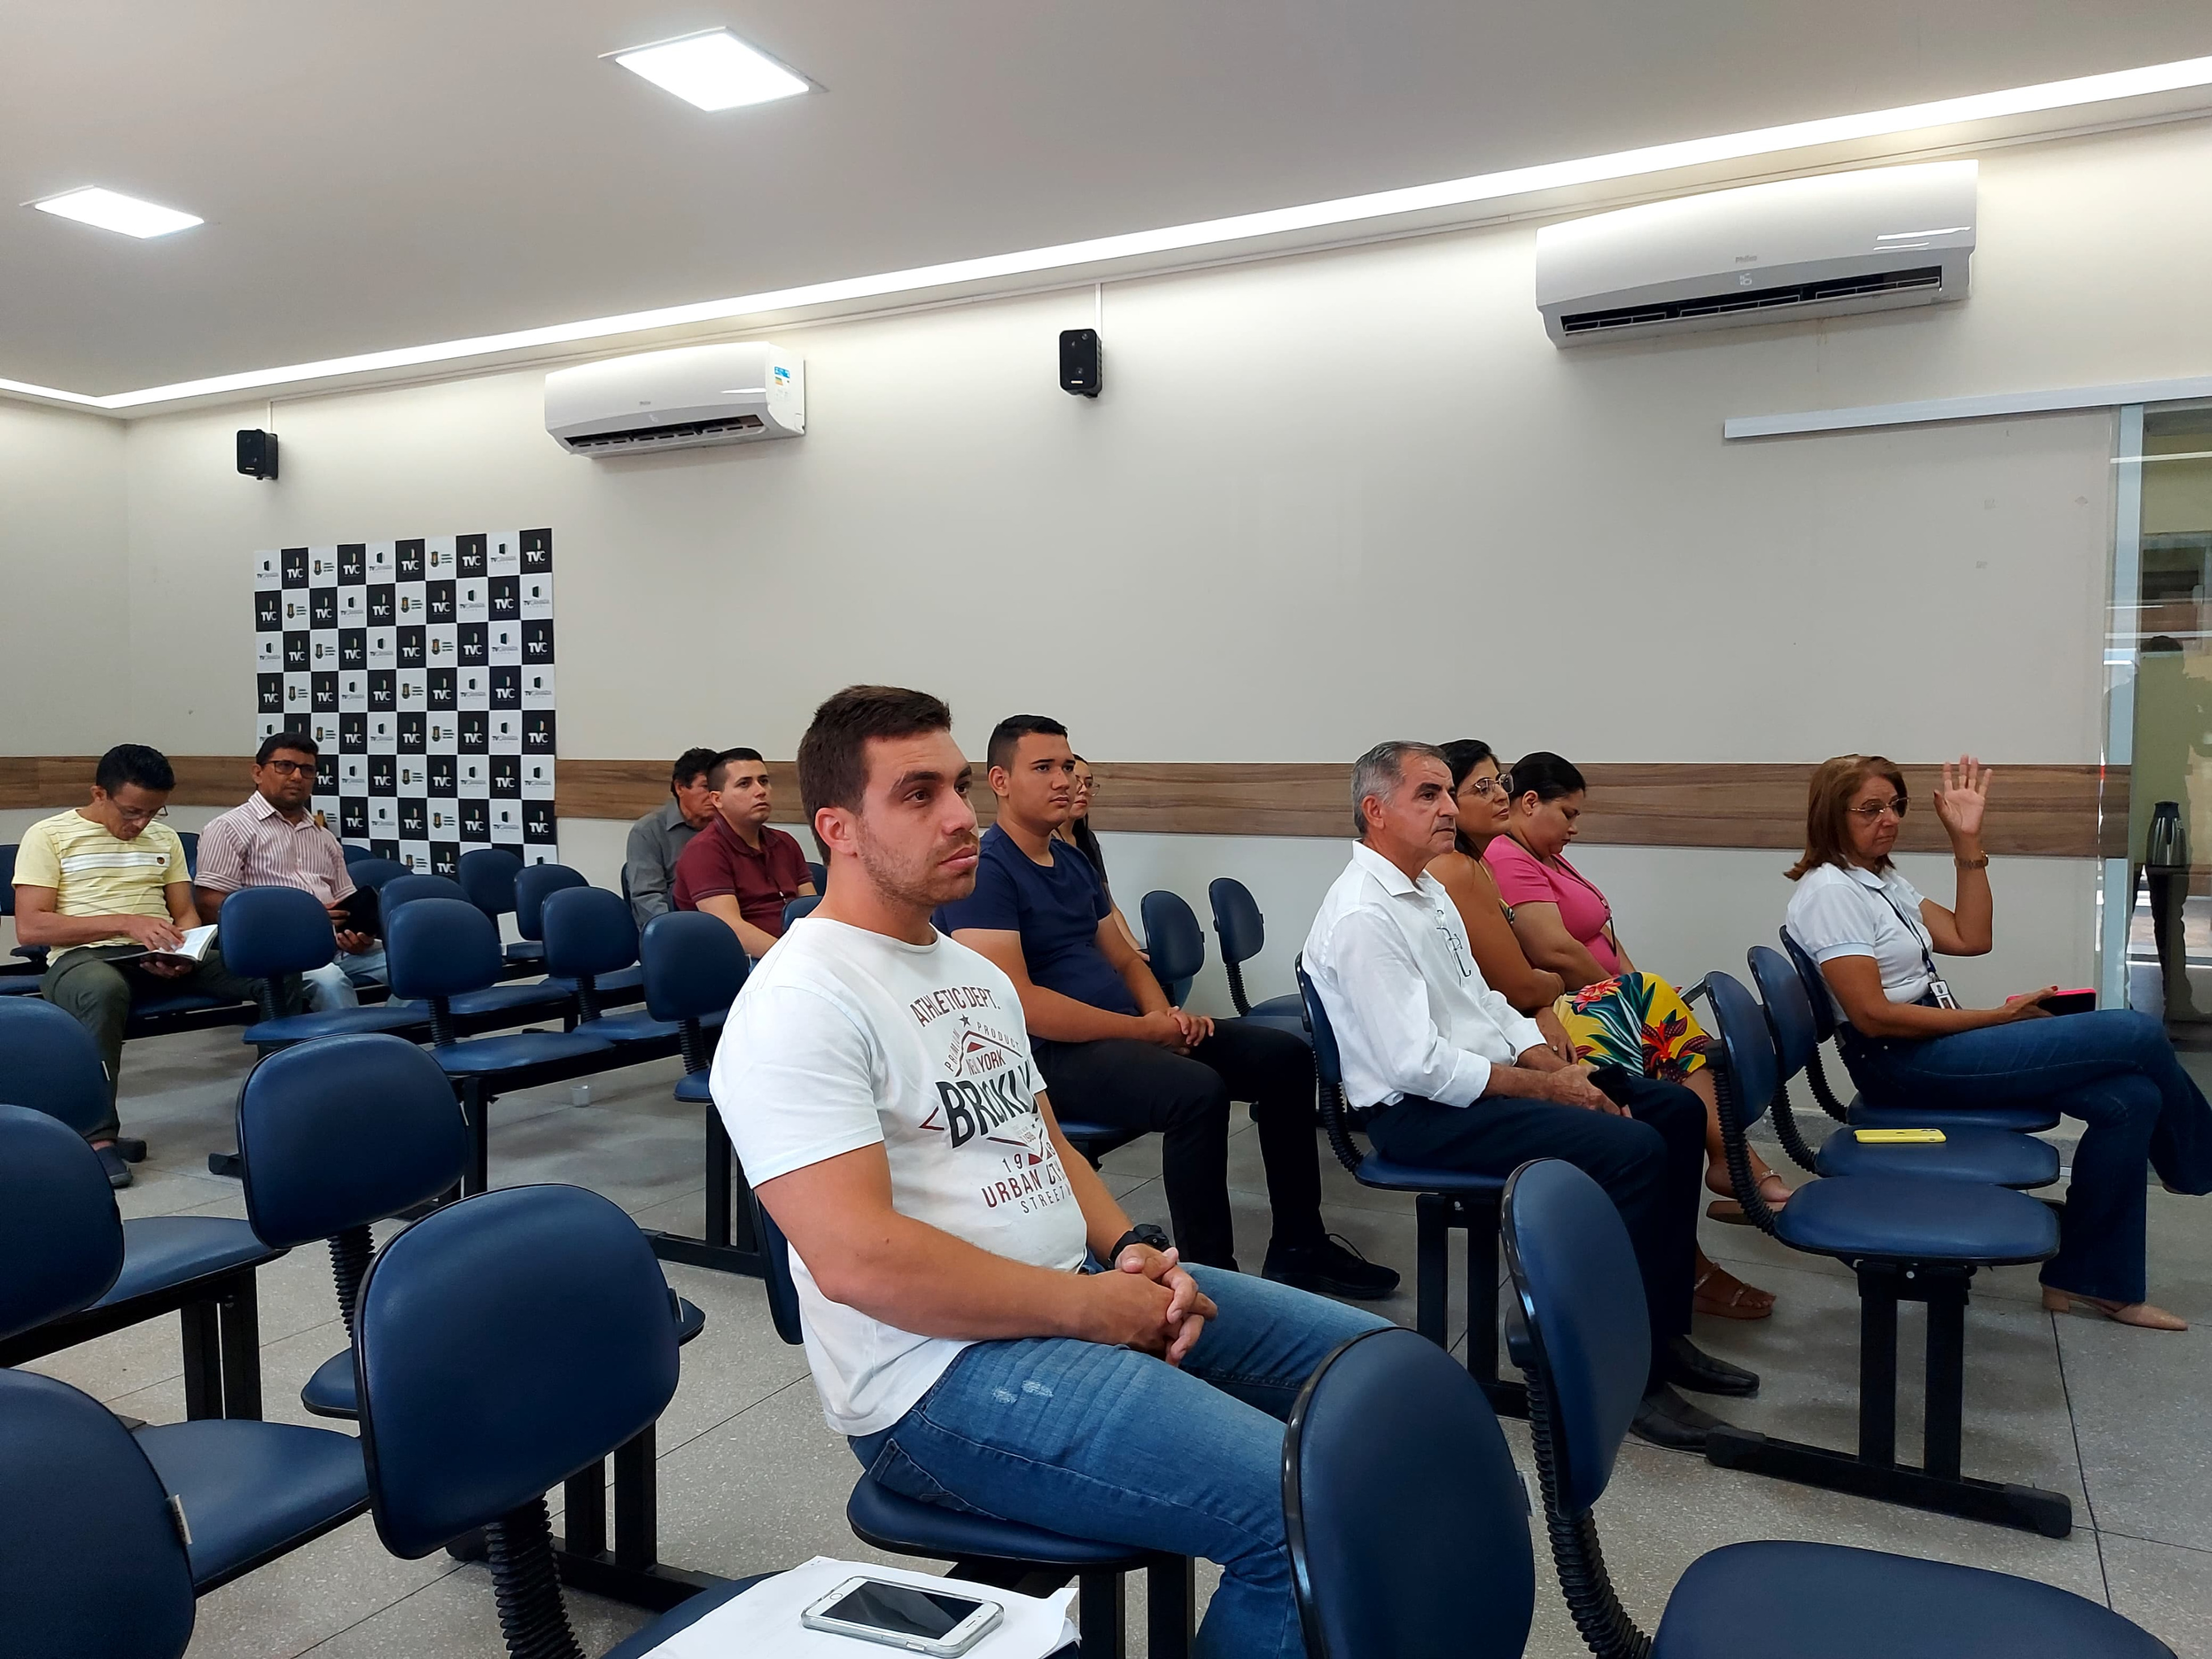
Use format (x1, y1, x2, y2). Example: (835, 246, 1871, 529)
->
(38, 1031, 2212, 1659)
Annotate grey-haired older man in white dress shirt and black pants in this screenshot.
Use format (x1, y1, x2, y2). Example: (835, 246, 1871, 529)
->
(1303, 743, 1758, 1449)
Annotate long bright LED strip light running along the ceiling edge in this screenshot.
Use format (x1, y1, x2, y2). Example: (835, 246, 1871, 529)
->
(13, 58, 2212, 409)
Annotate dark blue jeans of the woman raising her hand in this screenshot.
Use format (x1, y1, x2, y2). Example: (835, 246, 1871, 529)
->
(1838, 1009, 2212, 1303)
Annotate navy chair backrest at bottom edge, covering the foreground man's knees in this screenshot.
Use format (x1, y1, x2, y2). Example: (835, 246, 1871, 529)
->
(1283, 1327, 1535, 1659)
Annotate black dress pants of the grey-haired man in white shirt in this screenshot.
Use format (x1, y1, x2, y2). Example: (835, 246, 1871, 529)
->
(1367, 1066, 1705, 1382)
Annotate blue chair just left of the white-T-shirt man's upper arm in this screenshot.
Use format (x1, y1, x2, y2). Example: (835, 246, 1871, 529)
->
(639, 909, 761, 1274)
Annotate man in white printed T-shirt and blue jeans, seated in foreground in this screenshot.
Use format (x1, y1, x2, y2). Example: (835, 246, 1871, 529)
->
(712, 686, 1380, 1659)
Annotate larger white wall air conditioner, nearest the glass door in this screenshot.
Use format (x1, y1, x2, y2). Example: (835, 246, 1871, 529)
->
(1535, 162, 1975, 345)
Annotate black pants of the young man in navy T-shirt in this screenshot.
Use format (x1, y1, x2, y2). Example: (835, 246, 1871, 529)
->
(1028, 1020, 1318, 1268)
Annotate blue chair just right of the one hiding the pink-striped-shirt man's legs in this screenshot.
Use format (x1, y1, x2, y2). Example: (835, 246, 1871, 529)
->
(385, 898, 624, 1192)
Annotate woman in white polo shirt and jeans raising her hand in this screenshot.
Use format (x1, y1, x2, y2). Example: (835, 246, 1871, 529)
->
(1788, 754, 2212, 1332)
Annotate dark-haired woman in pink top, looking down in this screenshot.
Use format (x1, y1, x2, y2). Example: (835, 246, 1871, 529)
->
(1482, 750, 1789, 1221)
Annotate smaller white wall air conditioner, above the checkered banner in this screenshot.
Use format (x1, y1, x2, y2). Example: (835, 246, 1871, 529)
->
(546, 343, 807, 456)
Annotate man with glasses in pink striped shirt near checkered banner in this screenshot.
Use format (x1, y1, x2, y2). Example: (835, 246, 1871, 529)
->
(193, 732, 385, 1011)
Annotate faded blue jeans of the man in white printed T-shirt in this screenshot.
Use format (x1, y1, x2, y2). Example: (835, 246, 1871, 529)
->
(852, 1268, 1385, 1659)
